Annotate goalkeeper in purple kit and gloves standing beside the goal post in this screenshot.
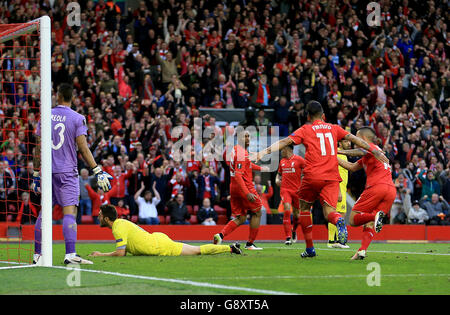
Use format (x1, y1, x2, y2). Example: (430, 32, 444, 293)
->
(31, 83, 112, 264)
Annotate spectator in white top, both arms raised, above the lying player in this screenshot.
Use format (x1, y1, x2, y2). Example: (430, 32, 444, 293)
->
(134, 182, 161, 225)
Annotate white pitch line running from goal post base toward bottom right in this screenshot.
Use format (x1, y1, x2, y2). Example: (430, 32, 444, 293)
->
(42, 266, 298, 295)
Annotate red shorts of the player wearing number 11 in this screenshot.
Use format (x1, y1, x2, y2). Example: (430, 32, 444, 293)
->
(298, 179, 339, 208)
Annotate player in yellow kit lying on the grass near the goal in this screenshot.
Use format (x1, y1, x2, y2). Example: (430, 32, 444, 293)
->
(89, 205, 242, 257)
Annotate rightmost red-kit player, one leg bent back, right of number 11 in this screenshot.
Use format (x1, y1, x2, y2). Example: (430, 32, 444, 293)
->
(338, 127, 397, 260)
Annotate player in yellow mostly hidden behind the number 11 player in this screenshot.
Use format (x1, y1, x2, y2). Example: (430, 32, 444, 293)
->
(327, 140, 351, 248)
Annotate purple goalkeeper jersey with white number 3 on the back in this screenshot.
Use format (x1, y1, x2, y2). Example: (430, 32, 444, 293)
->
(36, 105, 87, 174)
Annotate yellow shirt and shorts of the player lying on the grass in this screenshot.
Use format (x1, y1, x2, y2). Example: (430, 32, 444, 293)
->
(112, 219, 183, 256)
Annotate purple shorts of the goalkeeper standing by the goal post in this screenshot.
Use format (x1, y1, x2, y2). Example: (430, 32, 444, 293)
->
(52, 172, 80, 207)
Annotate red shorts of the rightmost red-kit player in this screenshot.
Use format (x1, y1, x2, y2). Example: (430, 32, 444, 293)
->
(352, 184, 397, 214)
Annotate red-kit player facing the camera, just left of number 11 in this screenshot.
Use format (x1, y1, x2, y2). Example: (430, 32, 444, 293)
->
(275, 145, 306, 245)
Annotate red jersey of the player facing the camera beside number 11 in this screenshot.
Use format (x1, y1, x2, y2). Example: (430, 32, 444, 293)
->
(278, 154, 306, 191)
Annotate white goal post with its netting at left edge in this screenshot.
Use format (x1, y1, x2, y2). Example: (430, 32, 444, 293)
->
(0, 16, 53, 266)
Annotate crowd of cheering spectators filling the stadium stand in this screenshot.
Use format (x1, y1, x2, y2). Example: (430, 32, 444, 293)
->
(0, 0, 450, 224)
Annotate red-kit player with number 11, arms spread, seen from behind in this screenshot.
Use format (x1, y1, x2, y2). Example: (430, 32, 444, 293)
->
(253, 101, 389, 258)
